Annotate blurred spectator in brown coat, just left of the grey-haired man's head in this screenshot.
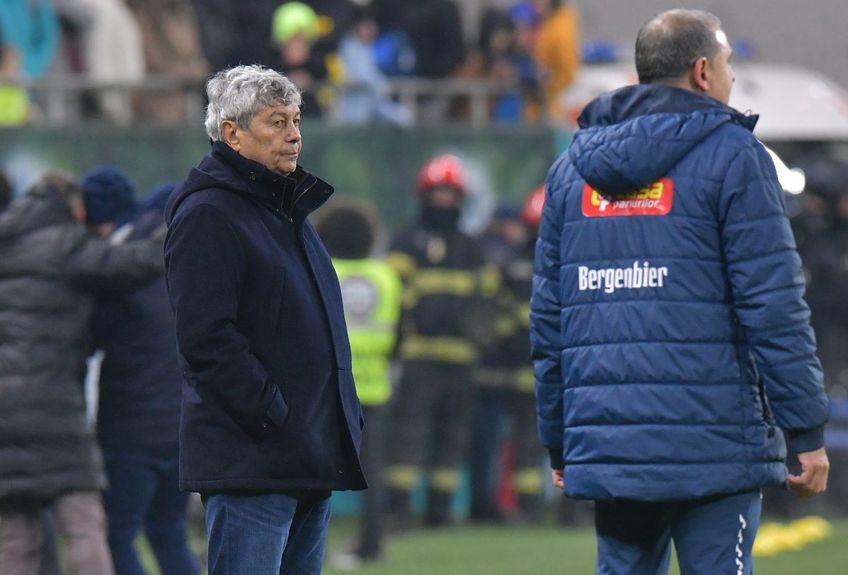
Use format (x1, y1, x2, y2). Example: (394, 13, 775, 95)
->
(125, 0, 210, 124)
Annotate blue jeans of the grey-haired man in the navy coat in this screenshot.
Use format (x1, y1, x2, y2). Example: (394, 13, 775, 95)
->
(203, 489, 330, 575)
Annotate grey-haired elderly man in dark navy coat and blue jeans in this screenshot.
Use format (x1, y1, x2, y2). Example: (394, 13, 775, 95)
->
(165, 66, 366, 575)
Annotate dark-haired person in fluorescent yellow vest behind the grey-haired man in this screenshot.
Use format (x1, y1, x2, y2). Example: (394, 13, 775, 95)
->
(315, 200, 402, 569)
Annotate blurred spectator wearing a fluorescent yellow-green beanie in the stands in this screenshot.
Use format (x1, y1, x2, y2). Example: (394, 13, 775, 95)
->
(271, 2, 329, 116)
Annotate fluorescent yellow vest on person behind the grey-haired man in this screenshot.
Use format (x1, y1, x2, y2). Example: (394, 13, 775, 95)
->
(333, 259, 402, 405)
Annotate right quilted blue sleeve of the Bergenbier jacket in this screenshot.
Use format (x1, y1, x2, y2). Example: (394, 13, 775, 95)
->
(719, 140, 828, 452)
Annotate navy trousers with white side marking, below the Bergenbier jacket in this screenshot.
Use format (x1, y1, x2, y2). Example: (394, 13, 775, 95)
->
(595, 491, 761, 575)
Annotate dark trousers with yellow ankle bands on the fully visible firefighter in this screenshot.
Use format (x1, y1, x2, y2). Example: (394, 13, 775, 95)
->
(385, 361, 473, 525)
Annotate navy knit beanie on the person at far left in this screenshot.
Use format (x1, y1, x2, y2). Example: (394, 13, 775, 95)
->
(80, 166, 137, 237)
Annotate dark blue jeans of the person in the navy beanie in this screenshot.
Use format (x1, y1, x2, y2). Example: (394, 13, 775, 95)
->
(103, 444, 198, 575)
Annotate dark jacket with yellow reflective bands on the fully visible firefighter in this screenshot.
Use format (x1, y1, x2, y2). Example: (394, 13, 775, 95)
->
(387, 227, 498, 365)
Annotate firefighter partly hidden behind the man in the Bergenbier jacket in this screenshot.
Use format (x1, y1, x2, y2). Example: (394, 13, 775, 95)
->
(470, 190, 544, 523)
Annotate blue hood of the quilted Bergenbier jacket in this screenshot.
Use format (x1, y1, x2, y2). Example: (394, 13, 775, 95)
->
(568, 84, 758, 197)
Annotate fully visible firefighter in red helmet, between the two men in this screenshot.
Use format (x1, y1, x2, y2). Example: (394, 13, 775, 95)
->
(386, 155, 497, 527)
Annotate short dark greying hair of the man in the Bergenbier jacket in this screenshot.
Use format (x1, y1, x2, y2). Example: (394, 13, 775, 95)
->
(636, 9, 721, 84)
